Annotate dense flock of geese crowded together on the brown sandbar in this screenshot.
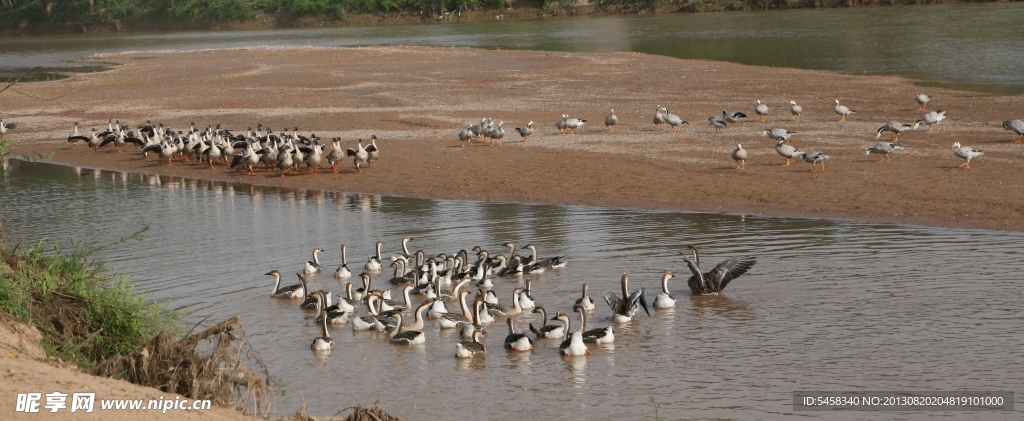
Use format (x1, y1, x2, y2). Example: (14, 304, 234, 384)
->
(65, 120, 380, 177)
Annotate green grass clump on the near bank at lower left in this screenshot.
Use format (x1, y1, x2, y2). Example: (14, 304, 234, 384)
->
(0, 227, 180, 367)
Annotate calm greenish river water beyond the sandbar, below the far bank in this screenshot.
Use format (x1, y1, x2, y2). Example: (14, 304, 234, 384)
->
(0, 2, 1024, 94)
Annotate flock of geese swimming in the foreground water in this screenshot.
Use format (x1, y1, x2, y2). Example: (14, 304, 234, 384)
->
(266, 238, 757, 359)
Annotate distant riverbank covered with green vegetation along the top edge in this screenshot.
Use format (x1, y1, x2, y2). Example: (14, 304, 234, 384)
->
(0, 0, 959, 37)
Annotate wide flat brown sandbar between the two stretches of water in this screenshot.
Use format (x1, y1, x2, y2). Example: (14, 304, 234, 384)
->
(4, 47, 1024, 234)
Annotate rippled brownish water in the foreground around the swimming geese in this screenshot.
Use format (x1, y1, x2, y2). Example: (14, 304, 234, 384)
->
(0, 162, 1024, 420)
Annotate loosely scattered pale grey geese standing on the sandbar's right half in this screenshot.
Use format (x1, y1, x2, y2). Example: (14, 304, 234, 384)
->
(459, 93, 1024, 172)
